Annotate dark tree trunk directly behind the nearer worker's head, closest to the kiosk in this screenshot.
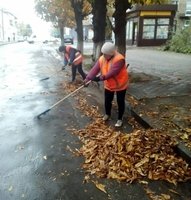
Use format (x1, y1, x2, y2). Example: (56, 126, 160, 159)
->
(113, 0, 131, 56)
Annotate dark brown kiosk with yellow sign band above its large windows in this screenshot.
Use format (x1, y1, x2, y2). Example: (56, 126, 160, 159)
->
(126, 5, 177, 46)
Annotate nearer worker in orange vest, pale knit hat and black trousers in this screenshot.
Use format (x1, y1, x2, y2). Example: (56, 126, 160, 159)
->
(84, 42, 128, 127)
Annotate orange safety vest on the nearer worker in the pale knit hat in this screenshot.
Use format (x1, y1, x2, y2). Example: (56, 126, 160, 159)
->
(99, 52, 128, 91)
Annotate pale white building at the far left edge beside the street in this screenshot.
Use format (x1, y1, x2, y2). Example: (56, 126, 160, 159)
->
(0, 8, 17, 42)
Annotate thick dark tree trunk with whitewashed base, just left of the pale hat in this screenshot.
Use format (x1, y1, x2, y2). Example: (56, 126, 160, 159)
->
(92, 0, 107, 60)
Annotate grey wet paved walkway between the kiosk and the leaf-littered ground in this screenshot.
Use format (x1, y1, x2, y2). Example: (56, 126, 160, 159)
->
(126, 48, 191, 98)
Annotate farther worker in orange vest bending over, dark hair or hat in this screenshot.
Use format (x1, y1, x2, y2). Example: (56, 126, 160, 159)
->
(59, 45, 86, 82)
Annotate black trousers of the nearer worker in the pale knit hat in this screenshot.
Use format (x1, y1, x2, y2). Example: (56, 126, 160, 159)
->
(105, 89, 126, 120)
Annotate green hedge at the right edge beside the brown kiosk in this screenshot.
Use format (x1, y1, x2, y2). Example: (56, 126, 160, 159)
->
(163, 27, 191, 54)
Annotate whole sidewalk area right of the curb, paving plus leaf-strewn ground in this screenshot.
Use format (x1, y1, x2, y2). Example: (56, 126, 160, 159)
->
(127, 48, 191, 163)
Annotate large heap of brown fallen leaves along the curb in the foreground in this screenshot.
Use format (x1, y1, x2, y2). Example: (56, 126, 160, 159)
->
(62, 82, 191, 184)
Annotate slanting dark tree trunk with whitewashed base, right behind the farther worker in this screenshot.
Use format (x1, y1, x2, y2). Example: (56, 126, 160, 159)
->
(71, 0, 83, 53)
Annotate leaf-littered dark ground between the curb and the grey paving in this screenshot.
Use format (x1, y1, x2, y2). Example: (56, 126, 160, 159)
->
(127, 96, 191, 150)
